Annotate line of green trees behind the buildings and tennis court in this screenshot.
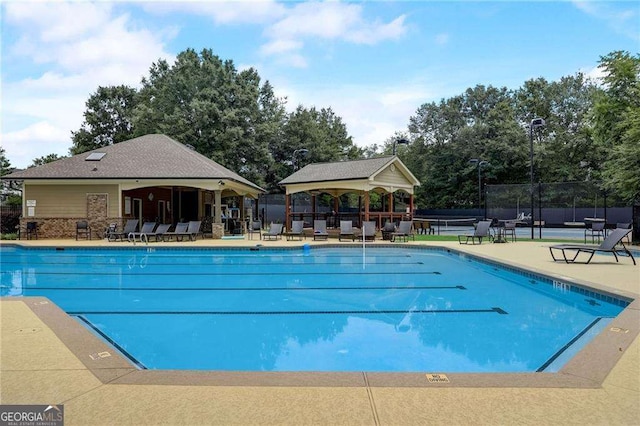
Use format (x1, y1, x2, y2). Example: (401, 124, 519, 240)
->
(0, 49, 640, 208)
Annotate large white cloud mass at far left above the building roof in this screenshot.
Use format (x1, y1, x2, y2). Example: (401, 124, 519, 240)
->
(2, 2, 175, 167)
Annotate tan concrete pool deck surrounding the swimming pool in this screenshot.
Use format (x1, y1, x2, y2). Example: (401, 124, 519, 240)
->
(0, 239, 640, 425)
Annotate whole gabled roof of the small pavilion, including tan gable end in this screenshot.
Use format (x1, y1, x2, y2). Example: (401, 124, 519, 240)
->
(279, 156, 420, 195)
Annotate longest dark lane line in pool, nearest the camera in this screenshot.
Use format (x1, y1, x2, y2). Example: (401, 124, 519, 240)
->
(67, 308, 508, 315)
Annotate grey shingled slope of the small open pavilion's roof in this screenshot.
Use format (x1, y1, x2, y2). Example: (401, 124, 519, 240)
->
(279, 156, 394, 185)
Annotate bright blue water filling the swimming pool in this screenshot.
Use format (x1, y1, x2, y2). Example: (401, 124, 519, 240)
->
(0, 243, 627, 372)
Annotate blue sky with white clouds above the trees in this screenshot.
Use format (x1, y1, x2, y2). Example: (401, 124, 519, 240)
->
(0, 0, 640, 167)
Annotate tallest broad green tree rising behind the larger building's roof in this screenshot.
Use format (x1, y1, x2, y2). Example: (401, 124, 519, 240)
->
(134, 49, 279, 184)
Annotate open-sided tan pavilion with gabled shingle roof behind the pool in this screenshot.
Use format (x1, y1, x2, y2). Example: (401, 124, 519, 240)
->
(279, 156, 420, 229)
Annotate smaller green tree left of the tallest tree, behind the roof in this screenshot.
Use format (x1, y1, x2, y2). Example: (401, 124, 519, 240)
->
(69, 85, 137, 155)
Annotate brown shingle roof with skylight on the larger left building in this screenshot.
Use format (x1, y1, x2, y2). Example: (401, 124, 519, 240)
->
(2, 134, 263, 191)
